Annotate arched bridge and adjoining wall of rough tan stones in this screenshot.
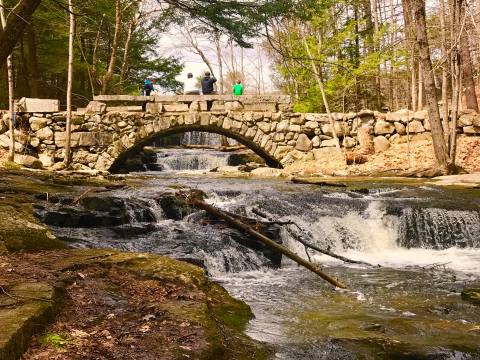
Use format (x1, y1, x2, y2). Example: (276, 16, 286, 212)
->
(0, 96, 480, 170)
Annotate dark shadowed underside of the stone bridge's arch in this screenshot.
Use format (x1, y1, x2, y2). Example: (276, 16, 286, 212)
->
(109, 125, 282, 173)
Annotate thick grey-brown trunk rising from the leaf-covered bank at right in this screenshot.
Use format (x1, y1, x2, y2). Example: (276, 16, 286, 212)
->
(403, 0, 454, 172)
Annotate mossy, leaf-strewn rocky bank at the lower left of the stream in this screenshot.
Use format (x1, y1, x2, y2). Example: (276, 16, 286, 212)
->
(0, 171, 269, 360)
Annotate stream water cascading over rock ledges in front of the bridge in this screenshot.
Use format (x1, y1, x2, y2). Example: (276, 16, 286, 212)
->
(39, 152, 480, 359)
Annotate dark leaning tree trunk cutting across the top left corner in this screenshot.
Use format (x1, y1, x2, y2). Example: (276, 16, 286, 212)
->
(0, 0, 42, 66)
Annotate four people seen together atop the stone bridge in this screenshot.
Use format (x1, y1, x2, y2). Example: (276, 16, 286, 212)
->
(143, 71, 240, 96)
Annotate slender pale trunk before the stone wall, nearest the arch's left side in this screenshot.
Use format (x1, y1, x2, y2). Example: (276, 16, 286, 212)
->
(64, 0, 75, 166)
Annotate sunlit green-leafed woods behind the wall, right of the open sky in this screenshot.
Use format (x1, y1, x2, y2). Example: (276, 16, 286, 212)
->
(265, 0, 480, 112)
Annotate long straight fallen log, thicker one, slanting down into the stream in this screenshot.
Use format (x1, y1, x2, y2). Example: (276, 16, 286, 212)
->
(187, 196, 346, 289)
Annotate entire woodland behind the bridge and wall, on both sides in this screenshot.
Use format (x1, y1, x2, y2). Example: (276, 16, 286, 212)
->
(0, 0, 479, 172)
